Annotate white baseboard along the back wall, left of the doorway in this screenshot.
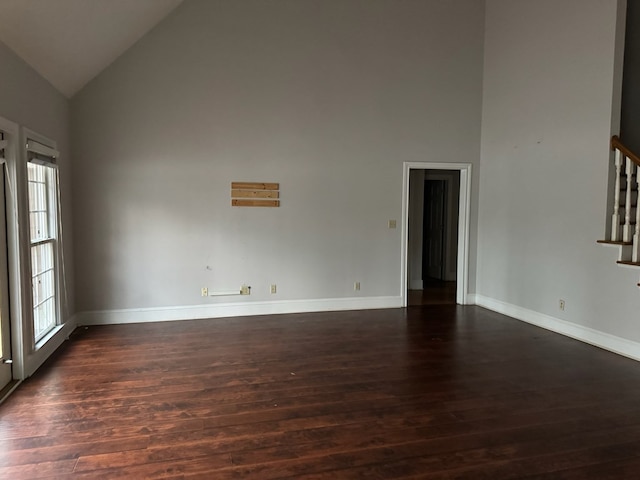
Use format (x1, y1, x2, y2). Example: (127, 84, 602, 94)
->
(76, 296, 402, 325)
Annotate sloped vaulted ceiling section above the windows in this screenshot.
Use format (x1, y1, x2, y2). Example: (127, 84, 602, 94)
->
(0, 0, 183, 98)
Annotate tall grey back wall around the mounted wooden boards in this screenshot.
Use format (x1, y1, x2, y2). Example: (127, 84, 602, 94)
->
(71, 0, 484, 318)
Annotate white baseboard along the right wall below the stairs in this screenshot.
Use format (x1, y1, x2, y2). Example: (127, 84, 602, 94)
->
(467, 294, 640, 361)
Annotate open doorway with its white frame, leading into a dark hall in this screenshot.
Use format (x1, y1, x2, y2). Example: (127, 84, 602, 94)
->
(402, 162, 471, 306)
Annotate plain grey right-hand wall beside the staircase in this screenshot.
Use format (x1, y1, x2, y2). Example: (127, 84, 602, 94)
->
(477, 0, 640, 348)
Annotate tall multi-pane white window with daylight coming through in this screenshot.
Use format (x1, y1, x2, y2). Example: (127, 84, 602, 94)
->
(27, 156, 59, 343)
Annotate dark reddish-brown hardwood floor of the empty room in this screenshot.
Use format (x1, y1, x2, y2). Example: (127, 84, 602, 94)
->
(0, 306, 640, 480)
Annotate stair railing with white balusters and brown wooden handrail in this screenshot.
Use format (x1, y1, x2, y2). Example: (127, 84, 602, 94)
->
(611, 135, 640, 263)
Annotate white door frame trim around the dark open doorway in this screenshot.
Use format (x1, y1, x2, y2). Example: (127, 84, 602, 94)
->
(400, 162, 472, 307)
